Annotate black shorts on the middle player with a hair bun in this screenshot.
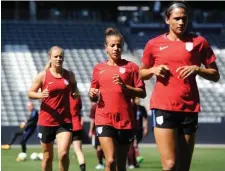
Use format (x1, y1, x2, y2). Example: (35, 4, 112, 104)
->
(96, 125, 134, 145)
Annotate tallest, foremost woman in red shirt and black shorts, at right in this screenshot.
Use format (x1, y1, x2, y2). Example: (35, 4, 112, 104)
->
(140, 2, 220, 171)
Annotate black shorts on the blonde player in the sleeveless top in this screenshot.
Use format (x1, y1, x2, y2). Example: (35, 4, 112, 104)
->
(38, 123, 72, 143)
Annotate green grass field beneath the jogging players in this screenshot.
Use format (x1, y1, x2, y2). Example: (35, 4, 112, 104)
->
(1, 146, 225, 171)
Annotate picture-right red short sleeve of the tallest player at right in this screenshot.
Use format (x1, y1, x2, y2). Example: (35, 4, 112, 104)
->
(200, 38, 216, 66)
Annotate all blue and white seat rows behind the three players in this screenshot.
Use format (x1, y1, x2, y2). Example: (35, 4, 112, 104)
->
(1, 21, 225, 126)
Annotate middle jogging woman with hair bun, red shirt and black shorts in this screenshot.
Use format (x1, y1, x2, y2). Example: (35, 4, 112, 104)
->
(89, 28, 146, 171)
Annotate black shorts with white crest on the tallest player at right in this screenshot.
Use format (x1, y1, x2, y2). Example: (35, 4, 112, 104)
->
(152, 109, 198, 135)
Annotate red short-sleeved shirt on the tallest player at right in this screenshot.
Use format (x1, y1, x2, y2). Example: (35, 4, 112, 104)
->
(142, 33, 216, 112)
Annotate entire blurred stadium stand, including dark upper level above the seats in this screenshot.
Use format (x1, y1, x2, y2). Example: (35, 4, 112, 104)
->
(1, 1, 225, 144)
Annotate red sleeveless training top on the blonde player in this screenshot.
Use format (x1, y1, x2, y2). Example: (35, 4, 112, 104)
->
(38, 69, 71, 126)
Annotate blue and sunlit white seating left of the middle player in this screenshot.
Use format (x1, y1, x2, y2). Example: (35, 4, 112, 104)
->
(1, 21, 113, 126)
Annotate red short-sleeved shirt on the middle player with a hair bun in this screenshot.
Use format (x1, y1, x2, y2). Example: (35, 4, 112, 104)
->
(91, 59, 144, 129)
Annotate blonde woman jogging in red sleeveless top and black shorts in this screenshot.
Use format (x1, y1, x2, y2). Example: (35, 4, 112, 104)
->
(28, 46, 77, 171)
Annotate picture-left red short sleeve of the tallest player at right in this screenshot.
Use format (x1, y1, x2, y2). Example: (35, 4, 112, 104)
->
(142, 40, 154, 68)
